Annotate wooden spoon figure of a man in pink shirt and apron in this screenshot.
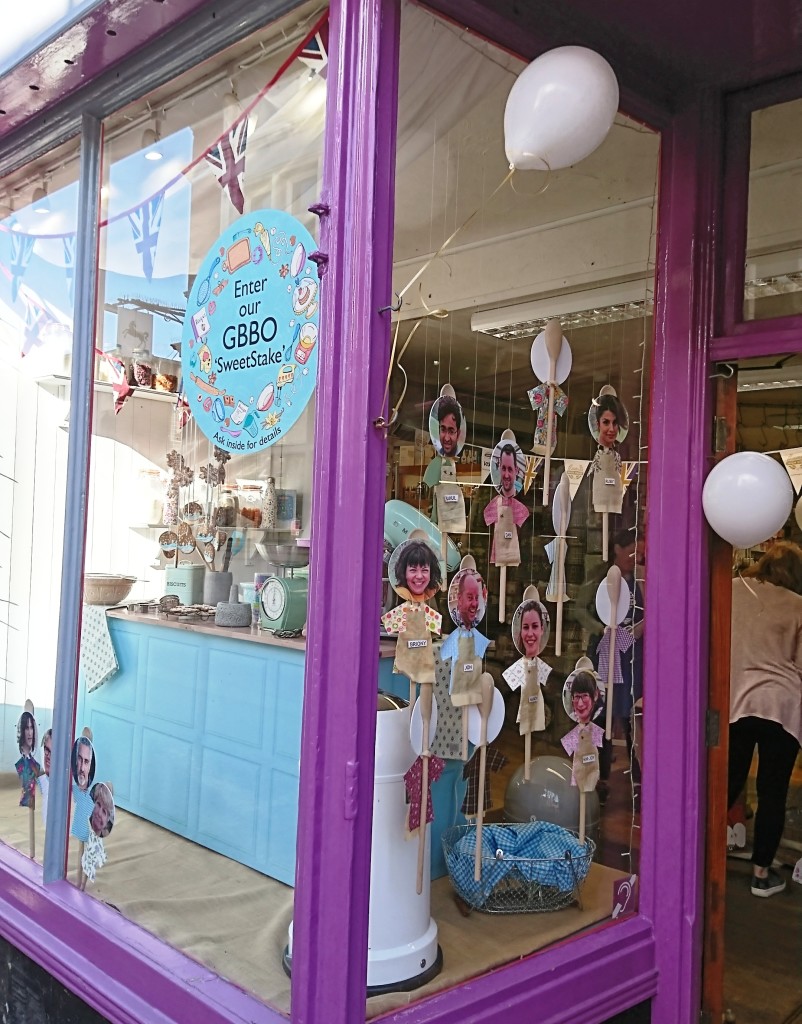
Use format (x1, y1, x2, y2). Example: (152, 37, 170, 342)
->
(484, 430, 530, 623)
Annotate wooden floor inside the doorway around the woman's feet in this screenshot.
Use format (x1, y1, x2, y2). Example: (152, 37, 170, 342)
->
(724, 756, 802, 1024)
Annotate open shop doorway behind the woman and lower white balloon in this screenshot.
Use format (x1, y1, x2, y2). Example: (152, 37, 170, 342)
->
(703, 355, 802, 1024)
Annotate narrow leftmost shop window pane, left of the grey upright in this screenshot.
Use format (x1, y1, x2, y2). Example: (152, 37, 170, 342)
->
(0, 139, 78, 860)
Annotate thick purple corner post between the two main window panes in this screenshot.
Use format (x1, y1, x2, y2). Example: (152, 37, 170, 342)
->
(292, 0, 398, 1024)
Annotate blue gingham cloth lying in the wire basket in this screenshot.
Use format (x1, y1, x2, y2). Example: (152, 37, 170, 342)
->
(446, 821, 590, 905)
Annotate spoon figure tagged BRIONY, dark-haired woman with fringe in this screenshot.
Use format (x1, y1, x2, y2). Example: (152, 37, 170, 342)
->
(382, 529, 442, 683)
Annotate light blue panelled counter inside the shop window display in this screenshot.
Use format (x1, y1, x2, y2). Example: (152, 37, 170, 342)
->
(77, 612, 464, 885)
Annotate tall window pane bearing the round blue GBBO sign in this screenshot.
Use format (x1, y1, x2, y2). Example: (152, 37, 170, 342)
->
(69, 0, 328, 1012)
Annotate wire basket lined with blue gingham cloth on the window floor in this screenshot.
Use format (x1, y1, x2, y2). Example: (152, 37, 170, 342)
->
(442, 821, 596, 913)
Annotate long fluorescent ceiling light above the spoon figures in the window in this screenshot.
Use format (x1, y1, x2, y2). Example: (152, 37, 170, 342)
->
(470, 278, 652, 338)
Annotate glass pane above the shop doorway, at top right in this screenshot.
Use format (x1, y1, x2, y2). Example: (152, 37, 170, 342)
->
(744, 99, 802, 321)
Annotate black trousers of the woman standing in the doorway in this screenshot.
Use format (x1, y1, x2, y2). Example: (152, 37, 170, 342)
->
(727, 716, 799, 867)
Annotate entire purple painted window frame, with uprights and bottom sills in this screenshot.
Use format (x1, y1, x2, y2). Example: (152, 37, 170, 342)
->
(0, 0, 782, 1024)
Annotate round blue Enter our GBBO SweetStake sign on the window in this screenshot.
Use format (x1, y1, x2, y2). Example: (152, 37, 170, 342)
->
(181, 210, 320, 454)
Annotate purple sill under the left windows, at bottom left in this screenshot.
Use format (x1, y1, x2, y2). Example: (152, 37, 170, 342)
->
(0, 846, 286, 1024)
